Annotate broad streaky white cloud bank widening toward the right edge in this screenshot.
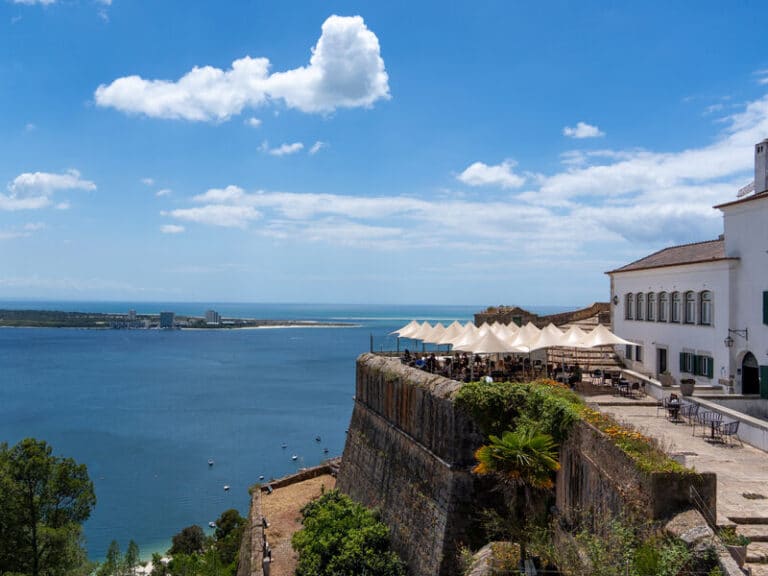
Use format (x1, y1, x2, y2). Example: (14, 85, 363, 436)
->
(163, 96, 768, 264)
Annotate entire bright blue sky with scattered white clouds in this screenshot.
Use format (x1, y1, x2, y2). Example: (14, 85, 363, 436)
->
(0, 0, 768, 306)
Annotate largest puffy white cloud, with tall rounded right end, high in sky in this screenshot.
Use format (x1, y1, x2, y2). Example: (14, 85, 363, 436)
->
(94, 16, 390, 122)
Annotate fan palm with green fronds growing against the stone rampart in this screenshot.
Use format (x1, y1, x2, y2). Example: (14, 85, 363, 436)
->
(472, 429, 560, 559)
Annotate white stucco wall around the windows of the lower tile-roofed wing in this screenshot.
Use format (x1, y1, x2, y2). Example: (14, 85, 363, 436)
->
(611, 260, 732, 384)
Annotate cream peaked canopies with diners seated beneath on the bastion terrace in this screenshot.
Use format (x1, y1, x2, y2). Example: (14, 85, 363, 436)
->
(391, 320, 633, 384)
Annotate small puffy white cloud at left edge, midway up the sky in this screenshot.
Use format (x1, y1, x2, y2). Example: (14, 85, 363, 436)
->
(0, 170, 96, 210)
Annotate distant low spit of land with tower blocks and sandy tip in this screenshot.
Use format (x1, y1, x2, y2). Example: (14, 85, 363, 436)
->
(0, 309, 357, 330)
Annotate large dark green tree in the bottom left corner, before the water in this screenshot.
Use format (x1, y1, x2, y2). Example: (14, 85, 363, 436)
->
(0, 438, 96, 576)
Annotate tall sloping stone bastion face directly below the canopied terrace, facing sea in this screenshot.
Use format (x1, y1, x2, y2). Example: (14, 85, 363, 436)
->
(337, 354, 482, 575)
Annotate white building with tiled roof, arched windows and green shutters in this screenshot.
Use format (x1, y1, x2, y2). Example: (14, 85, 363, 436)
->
(608, 139, 768, 398)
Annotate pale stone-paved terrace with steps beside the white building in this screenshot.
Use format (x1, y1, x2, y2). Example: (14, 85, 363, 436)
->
(586, 394, 768, 576)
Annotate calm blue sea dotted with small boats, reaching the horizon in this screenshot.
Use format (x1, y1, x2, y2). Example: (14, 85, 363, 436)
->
(0, 301, 563, 559)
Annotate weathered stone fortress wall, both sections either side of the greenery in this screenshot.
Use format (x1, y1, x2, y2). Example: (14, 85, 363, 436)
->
(337, 354, 715, 576)
